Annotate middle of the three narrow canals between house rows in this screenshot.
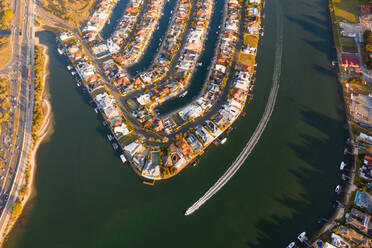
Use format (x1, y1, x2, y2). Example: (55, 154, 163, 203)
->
(127, 0, 178, 76)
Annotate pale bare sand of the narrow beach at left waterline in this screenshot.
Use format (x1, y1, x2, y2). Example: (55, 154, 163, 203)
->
(0, 38, 52, 244)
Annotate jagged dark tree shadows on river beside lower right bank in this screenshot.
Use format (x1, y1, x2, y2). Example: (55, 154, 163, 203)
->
(246, 109, 347, 248)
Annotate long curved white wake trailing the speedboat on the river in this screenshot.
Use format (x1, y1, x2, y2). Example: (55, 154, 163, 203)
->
(185, 4, 283, 215)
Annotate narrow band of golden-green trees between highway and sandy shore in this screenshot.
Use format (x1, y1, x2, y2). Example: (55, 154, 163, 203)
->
(32, 46, 45, 142)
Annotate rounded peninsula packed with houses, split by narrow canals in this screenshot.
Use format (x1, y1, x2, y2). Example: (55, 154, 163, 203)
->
(58, 0, 262, 180)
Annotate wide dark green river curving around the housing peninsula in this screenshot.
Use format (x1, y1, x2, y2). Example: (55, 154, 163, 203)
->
(5, 0, 347, 248)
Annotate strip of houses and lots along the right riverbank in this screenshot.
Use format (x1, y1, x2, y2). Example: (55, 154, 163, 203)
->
(313, 0, 372, 248)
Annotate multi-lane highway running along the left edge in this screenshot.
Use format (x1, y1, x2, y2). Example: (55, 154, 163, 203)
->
(0, 0, 35, 238)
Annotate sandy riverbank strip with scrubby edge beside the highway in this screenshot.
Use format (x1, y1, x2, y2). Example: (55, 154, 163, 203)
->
(0, 39, 52, 247)
